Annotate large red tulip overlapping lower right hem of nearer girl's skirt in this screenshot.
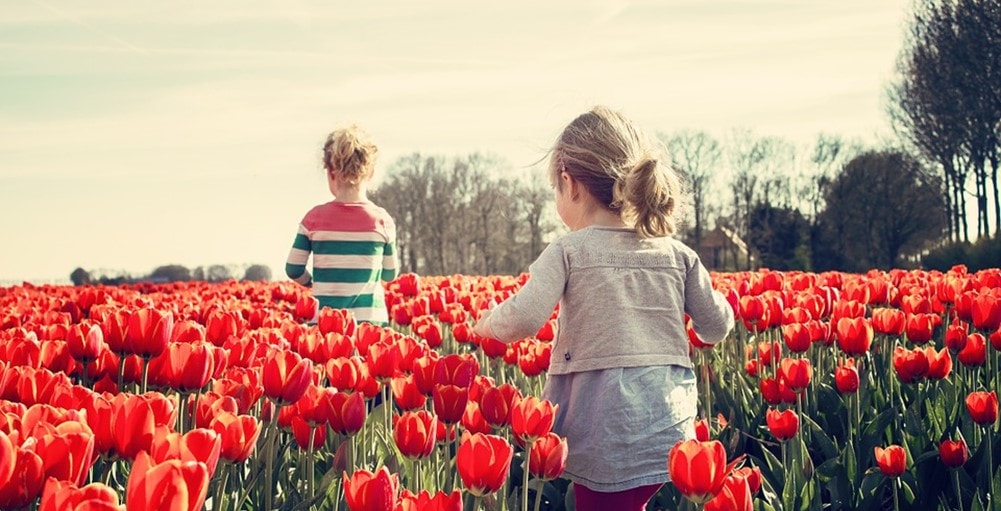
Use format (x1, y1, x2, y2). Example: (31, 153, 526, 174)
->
(668, 440, 728, 504)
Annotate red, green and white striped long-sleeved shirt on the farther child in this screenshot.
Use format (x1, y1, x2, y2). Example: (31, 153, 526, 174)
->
(285, 201, 396, 324)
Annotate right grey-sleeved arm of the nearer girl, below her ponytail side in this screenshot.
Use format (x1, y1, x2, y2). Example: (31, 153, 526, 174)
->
(685, 259, 734, 345)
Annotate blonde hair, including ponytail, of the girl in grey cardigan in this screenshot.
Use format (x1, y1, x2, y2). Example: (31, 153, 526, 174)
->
(550, 106, 684, 237)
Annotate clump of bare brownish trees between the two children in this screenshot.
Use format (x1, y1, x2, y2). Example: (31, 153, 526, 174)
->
(369, 153, 552, 275)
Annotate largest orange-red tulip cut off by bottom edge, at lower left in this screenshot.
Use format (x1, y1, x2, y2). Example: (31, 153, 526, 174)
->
(125, 451, 209, 511)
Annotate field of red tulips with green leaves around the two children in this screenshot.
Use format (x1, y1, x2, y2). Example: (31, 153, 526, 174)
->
(0, 267, 1001, 511)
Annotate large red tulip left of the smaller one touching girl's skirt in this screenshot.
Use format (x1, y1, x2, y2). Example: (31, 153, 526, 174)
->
(455, 433, 515, 497)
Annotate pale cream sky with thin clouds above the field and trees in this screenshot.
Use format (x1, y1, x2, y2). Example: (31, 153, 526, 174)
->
(0, 0, 910, 285)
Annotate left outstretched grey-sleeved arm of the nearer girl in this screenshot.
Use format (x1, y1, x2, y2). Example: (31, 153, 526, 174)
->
(473, 243, 568, 343)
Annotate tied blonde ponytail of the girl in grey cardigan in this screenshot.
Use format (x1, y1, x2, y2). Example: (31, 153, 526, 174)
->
(616, 156, 682, 237)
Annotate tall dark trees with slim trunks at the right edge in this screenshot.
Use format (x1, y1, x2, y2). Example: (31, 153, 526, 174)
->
(889, 0, 1001, 241)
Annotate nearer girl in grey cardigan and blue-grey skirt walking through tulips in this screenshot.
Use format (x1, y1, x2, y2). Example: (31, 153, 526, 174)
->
(475, 107, 734, 511)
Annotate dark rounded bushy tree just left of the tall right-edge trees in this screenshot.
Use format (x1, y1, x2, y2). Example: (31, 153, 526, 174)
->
(812, 150, 946, 272)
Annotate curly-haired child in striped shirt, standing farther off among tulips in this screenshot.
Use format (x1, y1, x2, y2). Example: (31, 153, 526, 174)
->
(285, 125, 396, 325)
